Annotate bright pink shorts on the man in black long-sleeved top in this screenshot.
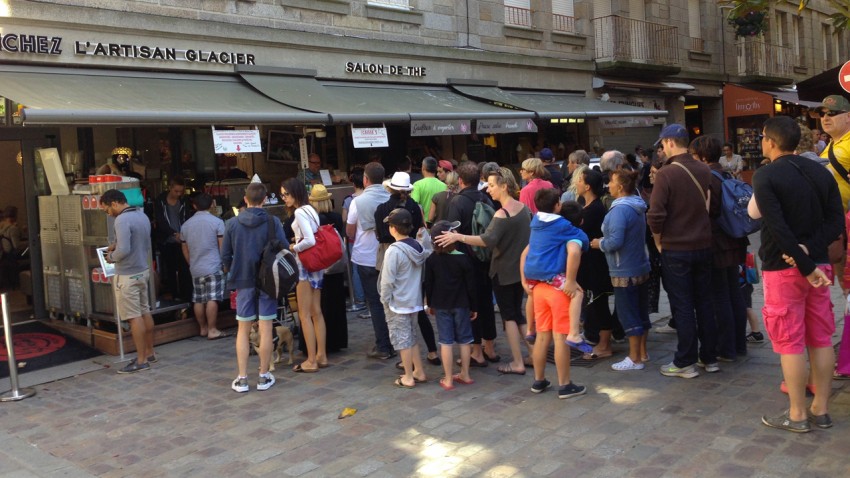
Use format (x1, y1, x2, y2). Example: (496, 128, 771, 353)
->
(762, 265, 835, 354)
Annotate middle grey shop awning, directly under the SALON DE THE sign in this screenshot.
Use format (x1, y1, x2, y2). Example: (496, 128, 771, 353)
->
(239, 69, 534, 124)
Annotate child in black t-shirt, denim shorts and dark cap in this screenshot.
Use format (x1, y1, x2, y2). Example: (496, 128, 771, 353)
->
(424, 221, 477, 390)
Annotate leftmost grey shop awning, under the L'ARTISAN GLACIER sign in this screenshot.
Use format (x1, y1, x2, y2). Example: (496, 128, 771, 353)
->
(0, 66, 329, 126)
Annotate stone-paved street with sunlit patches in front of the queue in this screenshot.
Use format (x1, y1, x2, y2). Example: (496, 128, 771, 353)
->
(0, 278, 850, 477)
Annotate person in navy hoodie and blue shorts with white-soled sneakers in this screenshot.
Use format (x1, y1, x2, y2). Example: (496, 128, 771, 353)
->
(221, 183, 289, 393)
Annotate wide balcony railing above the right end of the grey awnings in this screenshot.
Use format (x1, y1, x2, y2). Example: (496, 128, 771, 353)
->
(593, 15, 679, 66)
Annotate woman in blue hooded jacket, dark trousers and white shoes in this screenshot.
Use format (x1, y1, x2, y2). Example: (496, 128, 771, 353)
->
(590, 169, 651, 371)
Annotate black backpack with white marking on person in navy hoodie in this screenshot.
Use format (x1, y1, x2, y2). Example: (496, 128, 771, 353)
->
(256, 216, 298, 301)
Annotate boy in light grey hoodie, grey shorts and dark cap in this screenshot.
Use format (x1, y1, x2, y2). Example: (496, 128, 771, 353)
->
(380, 208, 431, 388)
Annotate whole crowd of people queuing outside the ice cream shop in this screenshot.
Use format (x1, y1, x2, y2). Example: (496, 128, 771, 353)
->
(101, 96, 850, 432)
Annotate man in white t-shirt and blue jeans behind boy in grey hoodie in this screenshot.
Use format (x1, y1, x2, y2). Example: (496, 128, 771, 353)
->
(345, 162, 396, 360)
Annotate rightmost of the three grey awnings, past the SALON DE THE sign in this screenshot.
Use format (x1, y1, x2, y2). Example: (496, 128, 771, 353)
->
(452, 85, 667, 119)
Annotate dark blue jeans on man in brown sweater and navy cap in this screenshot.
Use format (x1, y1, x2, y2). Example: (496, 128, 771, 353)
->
(661, 249, 717, 368)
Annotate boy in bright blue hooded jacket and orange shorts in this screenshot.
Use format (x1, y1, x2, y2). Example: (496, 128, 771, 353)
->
(520, 189, 588, 398)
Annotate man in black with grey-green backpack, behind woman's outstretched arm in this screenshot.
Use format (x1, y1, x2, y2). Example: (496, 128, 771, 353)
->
(447, 162, 501, 367)
